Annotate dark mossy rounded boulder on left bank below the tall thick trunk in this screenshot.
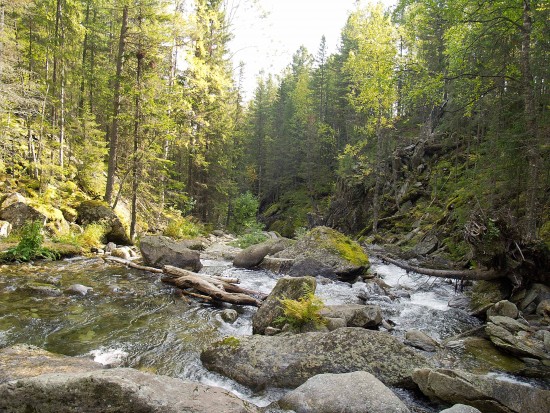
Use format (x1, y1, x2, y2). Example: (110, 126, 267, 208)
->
(76, 201, 132, 245)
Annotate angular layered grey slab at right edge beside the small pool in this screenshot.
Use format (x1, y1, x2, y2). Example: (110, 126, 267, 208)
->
(485, 316, 550, 360)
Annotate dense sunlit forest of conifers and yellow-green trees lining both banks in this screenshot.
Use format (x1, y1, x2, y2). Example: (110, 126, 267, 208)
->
(0, 0, 550, 271)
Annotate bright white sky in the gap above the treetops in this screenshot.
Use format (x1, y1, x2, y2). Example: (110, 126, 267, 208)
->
(230, 0, 395, 100)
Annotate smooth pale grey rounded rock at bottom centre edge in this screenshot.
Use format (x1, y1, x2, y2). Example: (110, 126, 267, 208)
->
(278, 371, 409, 413)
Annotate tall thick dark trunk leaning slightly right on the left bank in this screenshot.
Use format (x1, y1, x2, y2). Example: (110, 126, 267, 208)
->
(104, 5, 128, 204)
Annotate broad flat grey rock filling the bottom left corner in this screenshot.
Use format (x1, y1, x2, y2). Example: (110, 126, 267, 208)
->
(0, 368, 258, 413)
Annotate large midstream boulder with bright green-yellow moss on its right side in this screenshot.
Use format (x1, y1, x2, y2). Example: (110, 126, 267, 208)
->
(277, 227, 369, 278)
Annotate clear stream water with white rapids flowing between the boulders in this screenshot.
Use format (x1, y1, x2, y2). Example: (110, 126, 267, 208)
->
(0, 253, 504, 405)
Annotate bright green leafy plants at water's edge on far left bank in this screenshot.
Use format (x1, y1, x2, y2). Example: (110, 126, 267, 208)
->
(1, 221, 59, 262)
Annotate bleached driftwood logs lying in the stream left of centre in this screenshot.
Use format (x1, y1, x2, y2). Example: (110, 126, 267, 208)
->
(105, 257, 267, 307)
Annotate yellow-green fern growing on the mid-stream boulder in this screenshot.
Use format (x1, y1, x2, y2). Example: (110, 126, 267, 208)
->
(275, 288, 326, 331)
